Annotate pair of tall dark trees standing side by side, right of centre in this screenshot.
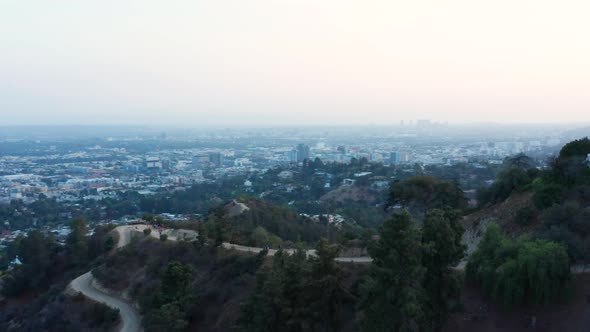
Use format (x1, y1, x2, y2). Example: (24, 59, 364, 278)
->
(359, 209, 465, 331)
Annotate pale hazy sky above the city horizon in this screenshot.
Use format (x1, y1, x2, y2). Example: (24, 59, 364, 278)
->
(0, 0, 590, 125)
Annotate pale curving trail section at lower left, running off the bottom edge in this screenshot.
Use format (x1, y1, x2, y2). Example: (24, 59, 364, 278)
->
(70, 272, 143, 332)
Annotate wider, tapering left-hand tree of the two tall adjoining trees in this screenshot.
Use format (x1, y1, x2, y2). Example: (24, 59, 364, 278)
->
(360, 211, 425, 331)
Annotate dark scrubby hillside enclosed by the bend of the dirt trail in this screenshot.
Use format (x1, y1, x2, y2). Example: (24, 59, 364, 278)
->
(93, 237, 366, 331)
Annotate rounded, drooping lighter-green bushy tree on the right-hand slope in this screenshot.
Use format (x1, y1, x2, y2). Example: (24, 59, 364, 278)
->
(466, 225, 570, 307)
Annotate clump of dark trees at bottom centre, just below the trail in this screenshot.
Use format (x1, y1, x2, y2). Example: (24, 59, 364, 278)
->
(236, 240, 353, 332)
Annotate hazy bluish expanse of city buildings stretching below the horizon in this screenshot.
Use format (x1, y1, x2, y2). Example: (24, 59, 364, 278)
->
(0, 127, 565, 204)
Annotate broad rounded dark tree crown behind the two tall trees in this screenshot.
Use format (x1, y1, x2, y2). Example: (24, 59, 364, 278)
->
(388, 176, 467, 209)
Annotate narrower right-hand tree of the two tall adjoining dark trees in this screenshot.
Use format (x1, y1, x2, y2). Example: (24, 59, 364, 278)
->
(422, 210, 465, 331)
